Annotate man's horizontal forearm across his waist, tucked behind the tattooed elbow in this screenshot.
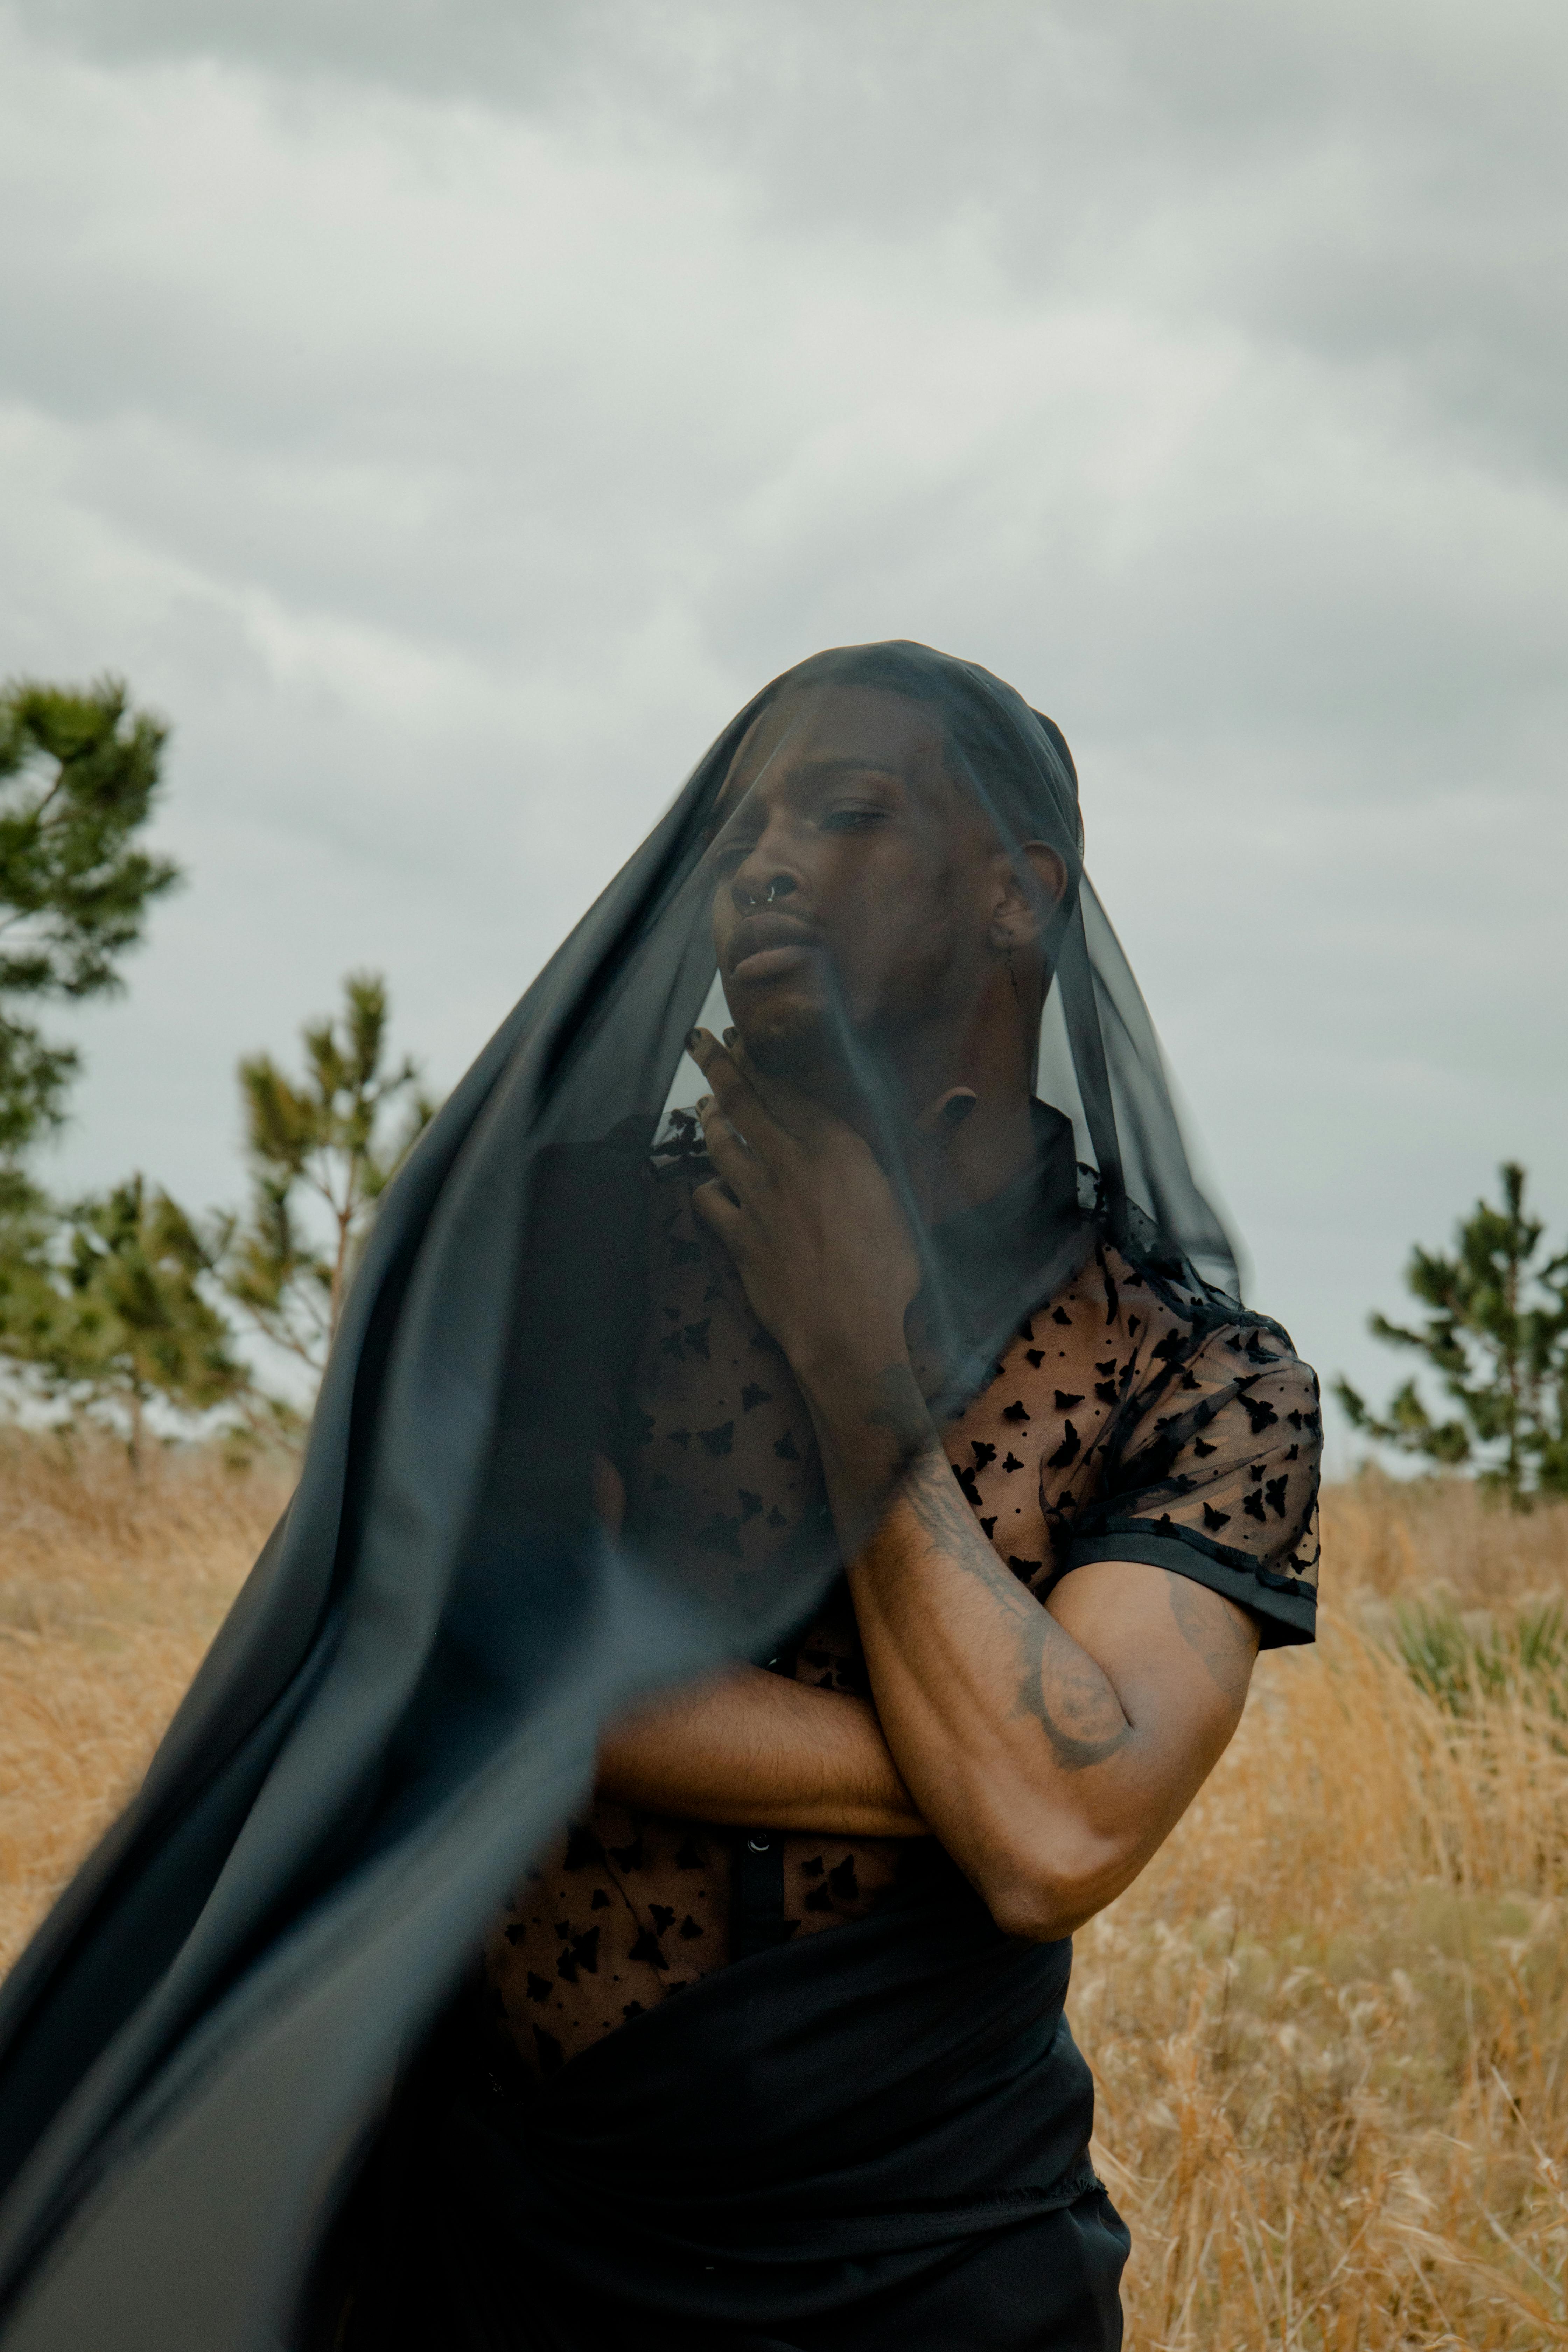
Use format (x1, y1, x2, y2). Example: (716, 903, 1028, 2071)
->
(600, 1665, 926, 1837)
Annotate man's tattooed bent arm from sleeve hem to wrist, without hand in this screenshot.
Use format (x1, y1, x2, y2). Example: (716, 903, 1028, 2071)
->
(811, 1359, 1258, 1940)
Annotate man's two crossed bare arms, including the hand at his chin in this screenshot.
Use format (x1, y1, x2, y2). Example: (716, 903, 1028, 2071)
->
(600, 1040, 1258, 1940)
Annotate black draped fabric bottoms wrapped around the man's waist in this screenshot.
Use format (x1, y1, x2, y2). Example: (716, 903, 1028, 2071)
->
(322, 1886, 1128, 2352)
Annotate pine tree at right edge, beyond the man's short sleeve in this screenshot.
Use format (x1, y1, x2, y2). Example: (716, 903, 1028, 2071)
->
(1335, 1162, 1568, 1510)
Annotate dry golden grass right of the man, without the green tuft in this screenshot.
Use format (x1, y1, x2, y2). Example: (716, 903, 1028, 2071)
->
(1091, 1479, 1568, 2352)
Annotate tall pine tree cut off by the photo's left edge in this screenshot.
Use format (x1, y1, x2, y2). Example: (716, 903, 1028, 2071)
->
(0, 677, 178, 1167)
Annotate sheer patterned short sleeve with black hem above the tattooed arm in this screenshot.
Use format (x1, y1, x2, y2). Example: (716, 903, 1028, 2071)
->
(1063, 1317, 1323, 1649)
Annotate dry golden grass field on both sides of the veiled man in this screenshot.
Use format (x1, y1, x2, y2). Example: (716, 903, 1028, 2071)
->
(0, 1440, 1568, 2352)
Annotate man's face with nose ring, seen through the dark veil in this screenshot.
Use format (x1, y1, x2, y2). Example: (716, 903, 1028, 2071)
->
(710, 687, 1025, 1077)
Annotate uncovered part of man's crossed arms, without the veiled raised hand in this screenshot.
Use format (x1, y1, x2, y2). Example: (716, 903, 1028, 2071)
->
(600, 1456, 1258, 1940)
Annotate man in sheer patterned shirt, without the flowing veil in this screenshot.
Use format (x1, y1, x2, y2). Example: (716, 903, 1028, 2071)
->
(341, 666, 1319, 2347)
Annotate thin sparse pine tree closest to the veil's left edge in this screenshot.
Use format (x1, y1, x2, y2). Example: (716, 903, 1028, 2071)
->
(216, 971, 433, 1371)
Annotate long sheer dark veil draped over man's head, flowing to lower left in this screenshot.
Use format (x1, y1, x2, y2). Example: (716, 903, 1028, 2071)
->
(0, 644, 1237, 2352)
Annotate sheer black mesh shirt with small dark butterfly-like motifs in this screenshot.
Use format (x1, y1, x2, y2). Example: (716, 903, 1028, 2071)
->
(484, 1115, 1321, 2072)
